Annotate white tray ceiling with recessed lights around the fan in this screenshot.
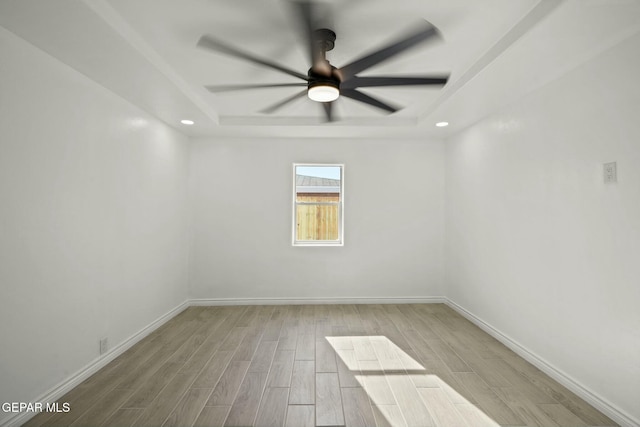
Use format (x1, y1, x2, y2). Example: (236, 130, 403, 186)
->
(0, 0, 640, 137)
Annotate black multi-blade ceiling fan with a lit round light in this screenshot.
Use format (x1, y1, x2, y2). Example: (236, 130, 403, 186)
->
(197, 1, 449, 122)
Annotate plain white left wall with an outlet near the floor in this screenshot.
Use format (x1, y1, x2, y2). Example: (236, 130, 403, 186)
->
(0, 28, 188, 424)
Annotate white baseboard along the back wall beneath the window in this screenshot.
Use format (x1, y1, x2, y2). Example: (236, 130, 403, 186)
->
(190, 297, 447, 306)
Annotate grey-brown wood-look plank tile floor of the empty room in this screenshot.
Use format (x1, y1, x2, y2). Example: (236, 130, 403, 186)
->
(25, 304, 615, 427)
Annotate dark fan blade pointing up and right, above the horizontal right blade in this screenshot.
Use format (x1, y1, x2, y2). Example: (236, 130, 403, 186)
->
(339, 21, 439, 81)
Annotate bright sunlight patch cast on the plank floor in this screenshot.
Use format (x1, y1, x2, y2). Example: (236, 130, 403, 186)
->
(326, 335, 499, 427)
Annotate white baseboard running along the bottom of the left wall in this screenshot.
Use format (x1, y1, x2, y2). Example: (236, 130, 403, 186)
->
(0, 300, 190, 427)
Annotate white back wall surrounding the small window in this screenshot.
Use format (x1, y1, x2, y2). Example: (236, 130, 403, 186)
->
(190, 139, 444, 299)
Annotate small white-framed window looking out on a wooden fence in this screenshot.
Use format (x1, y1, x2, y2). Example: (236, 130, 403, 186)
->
(293, 164, 344, 246)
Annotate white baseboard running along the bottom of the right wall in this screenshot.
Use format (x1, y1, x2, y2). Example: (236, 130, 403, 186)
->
(446, 298, 640, 427)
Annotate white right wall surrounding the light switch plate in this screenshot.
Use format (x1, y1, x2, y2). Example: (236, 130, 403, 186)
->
(446, 31, 640, 422)
